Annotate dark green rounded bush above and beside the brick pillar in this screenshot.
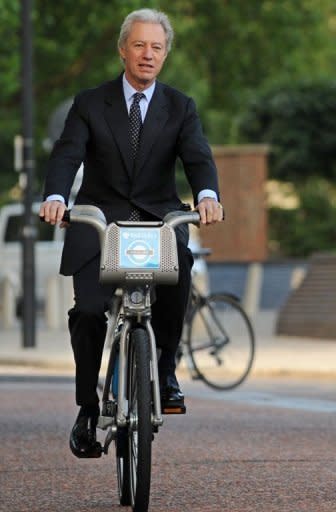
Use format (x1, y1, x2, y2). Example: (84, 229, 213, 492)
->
(239, 81, 336, 181)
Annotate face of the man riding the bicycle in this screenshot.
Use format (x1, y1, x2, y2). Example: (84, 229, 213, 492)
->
(119, 21, 167, 90)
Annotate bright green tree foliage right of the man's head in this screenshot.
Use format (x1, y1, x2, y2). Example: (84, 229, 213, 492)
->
(163, 0, 336, 140)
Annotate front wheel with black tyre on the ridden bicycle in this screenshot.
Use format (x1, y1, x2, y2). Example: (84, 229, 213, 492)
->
(124, 328, 152, 512)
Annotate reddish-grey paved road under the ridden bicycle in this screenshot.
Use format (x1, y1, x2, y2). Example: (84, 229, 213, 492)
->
(0, 376, 336, 512)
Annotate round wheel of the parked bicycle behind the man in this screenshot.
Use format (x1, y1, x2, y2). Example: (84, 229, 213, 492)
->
(187, 293, 255, 390)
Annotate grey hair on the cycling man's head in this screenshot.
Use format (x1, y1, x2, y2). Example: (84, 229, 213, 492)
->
(118, 9, 174, 53)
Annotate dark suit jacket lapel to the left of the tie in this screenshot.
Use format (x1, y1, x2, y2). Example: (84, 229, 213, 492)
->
(105, 77, 133, 176)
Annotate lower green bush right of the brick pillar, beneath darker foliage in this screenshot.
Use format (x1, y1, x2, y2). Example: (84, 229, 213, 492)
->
(269, 178, 336, 258)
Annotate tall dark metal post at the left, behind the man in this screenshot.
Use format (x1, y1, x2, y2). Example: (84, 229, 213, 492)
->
(21, 0, 36, 347)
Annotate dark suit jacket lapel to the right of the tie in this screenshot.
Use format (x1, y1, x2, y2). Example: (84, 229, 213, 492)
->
(134, 83, 169, 175)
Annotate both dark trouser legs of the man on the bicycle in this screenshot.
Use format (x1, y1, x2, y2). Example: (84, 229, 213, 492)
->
(69, 243, 193, 405)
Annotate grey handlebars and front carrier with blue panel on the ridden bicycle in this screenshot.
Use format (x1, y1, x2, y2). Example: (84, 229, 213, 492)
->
(40, 205, 200, 285)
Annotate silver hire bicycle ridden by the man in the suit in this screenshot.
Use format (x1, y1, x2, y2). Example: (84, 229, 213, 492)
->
(64, 205, 199, 512)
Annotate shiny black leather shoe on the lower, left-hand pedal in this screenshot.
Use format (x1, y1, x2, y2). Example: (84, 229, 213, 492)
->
(70, 413, 102, 459)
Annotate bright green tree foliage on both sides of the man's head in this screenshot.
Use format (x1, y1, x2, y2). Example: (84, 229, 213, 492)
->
(0, 0, 336, 202)
